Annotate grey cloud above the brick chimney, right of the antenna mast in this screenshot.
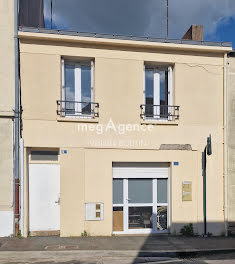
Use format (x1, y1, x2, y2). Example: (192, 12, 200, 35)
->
(169, 0, 235, 38)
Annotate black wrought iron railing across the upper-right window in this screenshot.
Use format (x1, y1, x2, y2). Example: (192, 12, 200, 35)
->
(140, 104, 179, 121)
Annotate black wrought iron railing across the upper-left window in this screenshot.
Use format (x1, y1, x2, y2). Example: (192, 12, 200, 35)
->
(56, 100, 99, 118)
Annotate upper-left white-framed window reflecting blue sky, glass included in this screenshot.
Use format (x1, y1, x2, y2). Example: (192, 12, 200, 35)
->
(61, 59, 95, 117)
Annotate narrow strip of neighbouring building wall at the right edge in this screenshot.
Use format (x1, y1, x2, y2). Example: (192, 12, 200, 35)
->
(228, 53, 235, 233)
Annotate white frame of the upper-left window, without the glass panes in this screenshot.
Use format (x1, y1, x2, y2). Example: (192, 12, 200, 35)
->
(61, 59, 94, 118)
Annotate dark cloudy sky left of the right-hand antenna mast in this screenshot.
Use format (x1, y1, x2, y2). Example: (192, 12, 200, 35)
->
(47, 0, 166, 38)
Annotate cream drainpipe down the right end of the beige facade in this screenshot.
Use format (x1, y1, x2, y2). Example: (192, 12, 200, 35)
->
(223, 54, 228, 236)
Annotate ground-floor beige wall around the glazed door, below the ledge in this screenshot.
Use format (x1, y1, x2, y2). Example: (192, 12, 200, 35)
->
(60, 148, 224, 236)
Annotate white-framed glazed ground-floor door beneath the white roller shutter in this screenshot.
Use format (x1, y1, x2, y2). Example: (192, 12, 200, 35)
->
(113, 178, 168, 233)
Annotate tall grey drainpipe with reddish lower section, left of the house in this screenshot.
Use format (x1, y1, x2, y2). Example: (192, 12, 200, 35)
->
(14, 0, 20, 235)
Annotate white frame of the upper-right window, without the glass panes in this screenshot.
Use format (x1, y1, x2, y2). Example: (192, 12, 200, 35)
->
(143, 65, 174, 121)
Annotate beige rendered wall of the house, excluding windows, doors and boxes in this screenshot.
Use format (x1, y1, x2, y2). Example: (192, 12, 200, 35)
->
(20, 34, 224, 236)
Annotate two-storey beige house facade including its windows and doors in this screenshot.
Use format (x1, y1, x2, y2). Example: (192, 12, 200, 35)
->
(19, 30, 231, 237)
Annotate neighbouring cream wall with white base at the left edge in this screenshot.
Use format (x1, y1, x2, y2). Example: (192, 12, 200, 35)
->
(0, 0, 15, 237)
